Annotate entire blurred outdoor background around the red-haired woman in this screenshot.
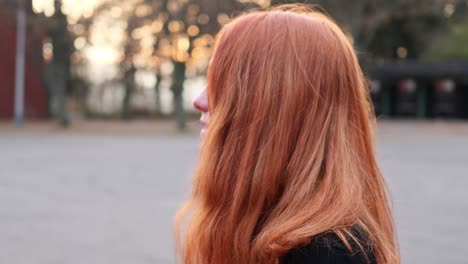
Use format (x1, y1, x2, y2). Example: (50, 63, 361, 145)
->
(0, 0, 468, 264)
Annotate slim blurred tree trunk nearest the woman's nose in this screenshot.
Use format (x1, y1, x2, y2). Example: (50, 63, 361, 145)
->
(171, 61, 187, 130)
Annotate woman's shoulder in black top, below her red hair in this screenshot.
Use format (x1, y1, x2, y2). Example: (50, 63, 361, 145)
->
(281, 233, 377, 264)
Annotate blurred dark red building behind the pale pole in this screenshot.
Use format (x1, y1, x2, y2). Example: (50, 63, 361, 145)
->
(0, 0, 47, 119)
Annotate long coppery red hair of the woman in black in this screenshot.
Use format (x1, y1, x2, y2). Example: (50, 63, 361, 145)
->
(175, 5, 400, 264)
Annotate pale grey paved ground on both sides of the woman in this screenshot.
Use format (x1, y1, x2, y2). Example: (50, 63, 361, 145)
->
(0, 122, 468, 264)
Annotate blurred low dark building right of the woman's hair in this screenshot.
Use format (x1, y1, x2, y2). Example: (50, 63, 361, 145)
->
(366, 63, 468, 119)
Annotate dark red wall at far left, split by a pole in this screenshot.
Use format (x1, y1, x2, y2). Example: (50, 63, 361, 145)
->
(0, 10, 47, 119)
